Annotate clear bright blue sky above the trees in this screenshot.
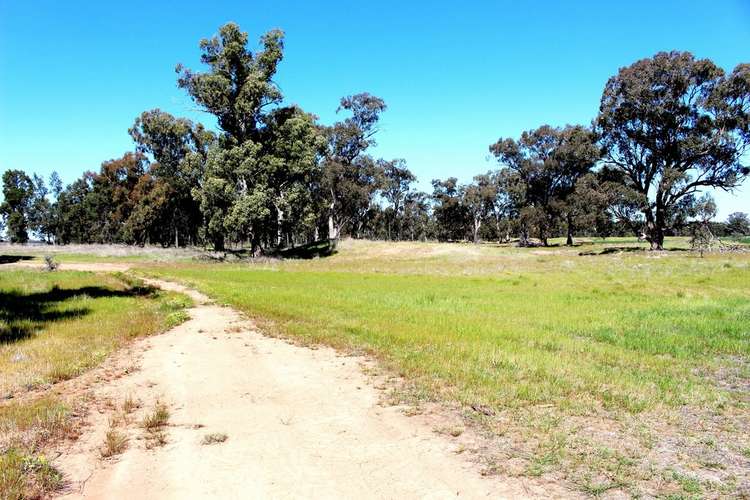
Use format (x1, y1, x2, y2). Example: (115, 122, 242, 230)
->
(0, 0, 750, 218)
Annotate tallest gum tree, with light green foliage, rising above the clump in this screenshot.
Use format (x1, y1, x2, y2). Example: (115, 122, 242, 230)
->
(177, 23, 319, 251)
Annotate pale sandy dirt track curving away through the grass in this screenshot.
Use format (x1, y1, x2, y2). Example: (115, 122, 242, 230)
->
(41, 272, 560, 499)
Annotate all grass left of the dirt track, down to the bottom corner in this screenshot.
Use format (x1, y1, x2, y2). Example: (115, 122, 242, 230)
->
(0, 270, 189, 498)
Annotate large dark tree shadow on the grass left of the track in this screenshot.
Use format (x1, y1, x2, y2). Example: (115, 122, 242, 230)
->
(0, 286, 155, 345)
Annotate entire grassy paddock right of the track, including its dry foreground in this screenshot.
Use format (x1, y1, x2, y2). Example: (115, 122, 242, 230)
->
(150, 241, 750, 495)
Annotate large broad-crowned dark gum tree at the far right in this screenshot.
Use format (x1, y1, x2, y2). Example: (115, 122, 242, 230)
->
(596, 52, 750, 250)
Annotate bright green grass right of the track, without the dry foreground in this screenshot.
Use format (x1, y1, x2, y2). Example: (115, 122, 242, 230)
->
(150, 246, 750, 412)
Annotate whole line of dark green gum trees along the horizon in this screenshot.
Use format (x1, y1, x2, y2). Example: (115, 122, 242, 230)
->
(0, 23, 750, 253)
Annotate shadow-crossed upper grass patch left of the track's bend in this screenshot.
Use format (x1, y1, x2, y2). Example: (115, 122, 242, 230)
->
(0, 270, 192, 397)
